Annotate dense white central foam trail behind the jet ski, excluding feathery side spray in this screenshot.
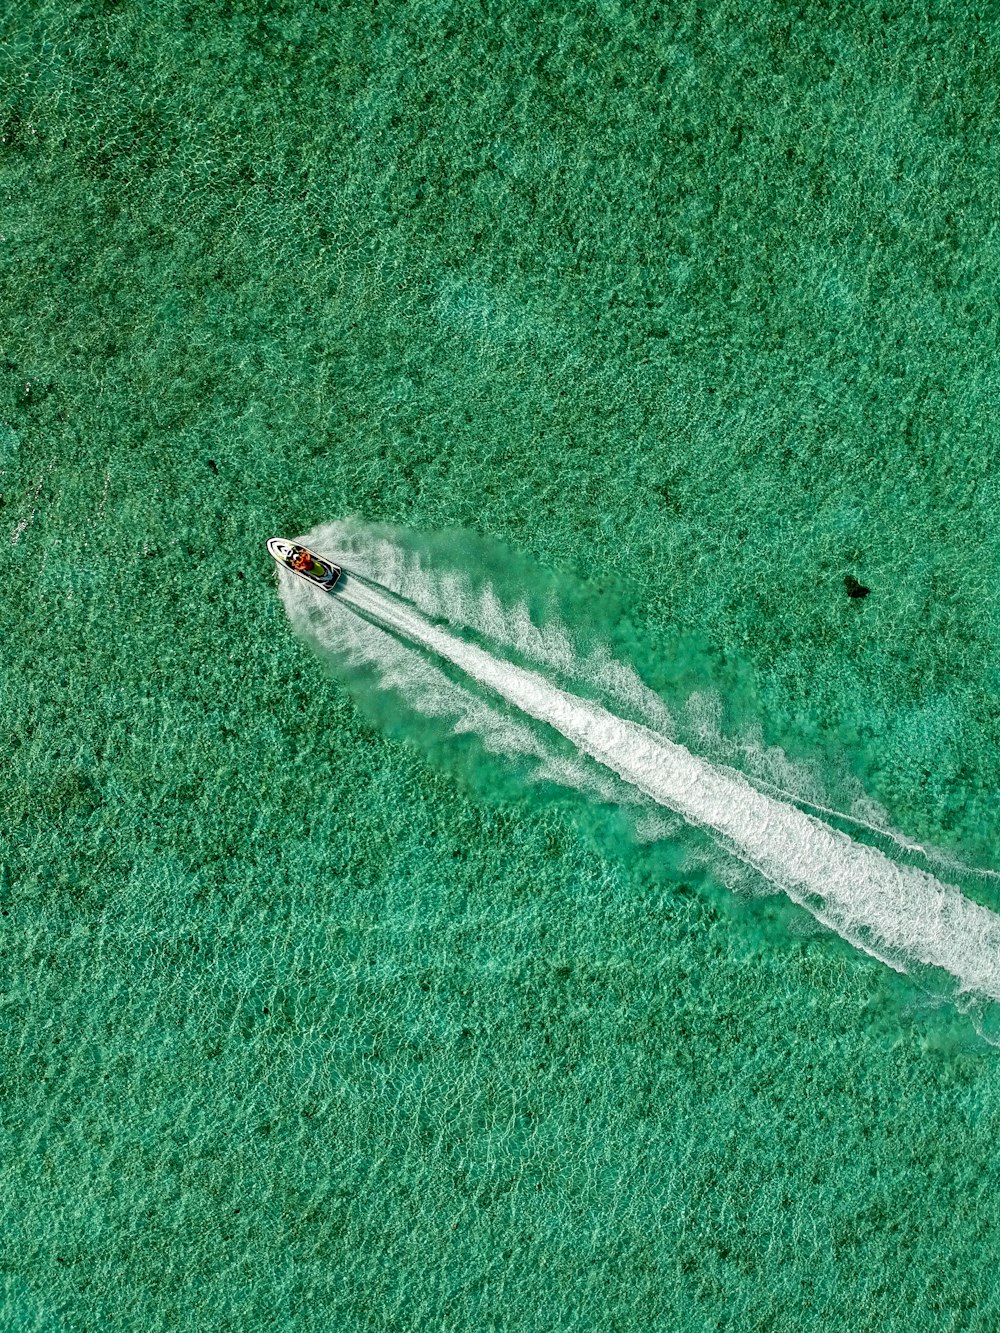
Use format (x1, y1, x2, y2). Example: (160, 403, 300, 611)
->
(274, 525, 1000, 1001)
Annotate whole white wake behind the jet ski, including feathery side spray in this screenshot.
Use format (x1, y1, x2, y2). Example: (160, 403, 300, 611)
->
(281, 519, 1000, 1000)
